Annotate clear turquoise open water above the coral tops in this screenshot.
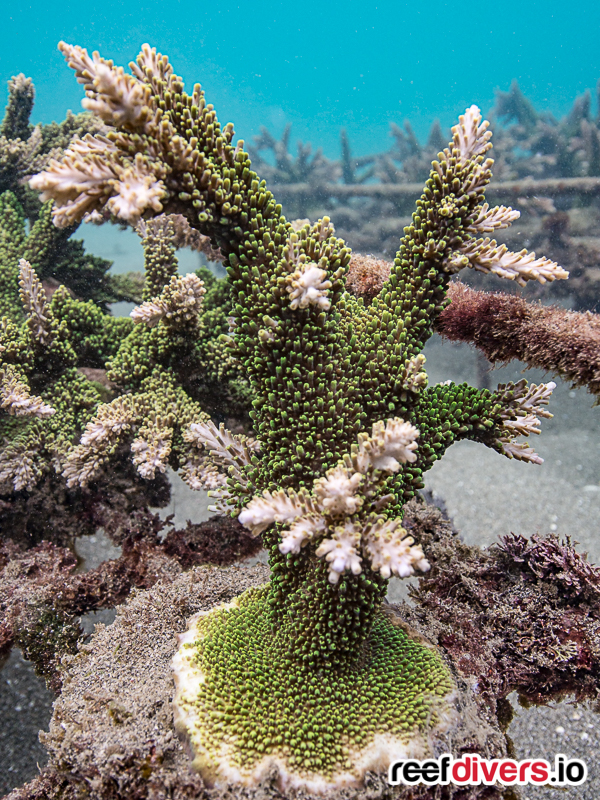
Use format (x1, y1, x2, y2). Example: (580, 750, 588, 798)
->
(0, 0, 600, 157)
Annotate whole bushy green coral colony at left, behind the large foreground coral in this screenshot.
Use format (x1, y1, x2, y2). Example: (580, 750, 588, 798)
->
(0, 67, 255, 544)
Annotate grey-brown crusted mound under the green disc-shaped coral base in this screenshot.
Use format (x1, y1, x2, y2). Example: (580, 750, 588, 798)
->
(29, 564, 506, 800)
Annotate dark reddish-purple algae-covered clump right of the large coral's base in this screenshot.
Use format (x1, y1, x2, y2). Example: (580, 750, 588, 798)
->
(402, 501, 600, 711)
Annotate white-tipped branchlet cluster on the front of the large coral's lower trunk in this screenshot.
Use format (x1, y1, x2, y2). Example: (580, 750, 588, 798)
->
(238, 417, 429, 583)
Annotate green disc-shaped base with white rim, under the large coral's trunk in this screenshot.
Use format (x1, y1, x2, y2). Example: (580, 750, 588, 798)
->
(174, 585, 454, 792)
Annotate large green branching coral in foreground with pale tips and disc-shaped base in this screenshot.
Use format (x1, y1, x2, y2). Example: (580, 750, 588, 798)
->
(31, 44, 566, 791)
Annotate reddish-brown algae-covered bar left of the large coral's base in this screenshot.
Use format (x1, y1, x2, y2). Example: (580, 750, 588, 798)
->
(0, 514, 261, 692)
